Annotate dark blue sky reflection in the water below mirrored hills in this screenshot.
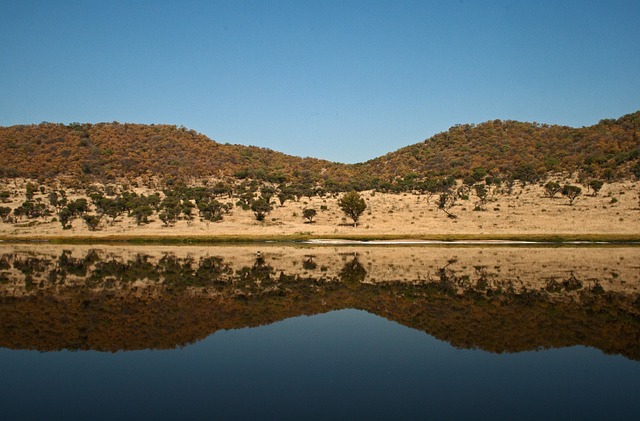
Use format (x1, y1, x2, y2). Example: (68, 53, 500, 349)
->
(0, 309, 640, 419)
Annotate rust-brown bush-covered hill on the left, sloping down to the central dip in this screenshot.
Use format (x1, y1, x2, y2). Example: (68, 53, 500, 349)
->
(0, 122, 346, 186)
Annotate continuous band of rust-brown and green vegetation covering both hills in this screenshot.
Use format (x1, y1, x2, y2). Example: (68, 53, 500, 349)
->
(0, 111, 640, 191)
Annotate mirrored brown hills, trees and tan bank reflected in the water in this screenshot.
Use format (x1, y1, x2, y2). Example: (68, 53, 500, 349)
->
(0, 245, 640, 360)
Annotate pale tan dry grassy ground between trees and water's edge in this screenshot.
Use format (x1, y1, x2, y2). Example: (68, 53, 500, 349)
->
(0, 177, 640, 239)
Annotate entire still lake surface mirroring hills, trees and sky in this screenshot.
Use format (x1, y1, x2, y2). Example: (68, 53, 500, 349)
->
(0, 246, 640, 419)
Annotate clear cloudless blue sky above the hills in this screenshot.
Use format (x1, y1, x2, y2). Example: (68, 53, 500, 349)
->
(0, 0, 640, 163)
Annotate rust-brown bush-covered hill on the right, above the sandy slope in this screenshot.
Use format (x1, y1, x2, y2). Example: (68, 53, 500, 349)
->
(366, 111, 640, 185)
